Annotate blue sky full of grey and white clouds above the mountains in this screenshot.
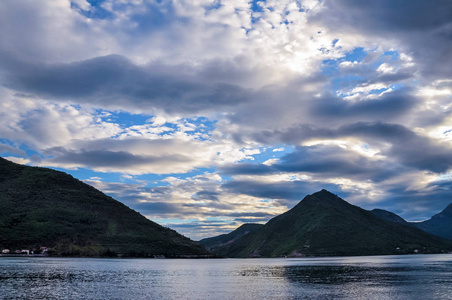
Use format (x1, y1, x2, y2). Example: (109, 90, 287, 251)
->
(0, 0, 452, 240)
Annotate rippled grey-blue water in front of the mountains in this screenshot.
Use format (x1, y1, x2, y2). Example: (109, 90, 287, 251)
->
(0, 254, 452, 300)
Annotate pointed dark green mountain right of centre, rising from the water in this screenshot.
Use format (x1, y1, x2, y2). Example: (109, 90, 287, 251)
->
(215, 190, 452, 257)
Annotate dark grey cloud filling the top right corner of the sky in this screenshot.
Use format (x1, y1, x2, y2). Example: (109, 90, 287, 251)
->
(312, 0, 452, 77)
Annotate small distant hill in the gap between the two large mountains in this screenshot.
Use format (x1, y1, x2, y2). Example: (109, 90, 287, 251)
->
(199, 223, 264, 255)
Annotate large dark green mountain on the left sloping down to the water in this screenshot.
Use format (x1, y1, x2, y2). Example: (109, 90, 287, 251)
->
(0, 158, 208, 256)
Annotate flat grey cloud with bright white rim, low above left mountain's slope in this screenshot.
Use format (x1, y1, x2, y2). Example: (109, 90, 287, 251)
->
(36, 137, 214, 174)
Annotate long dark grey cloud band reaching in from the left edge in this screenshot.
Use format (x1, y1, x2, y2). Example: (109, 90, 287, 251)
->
(0, 55, 249, 113)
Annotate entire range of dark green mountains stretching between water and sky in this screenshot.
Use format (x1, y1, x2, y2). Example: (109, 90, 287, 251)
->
(0, 158, 452, 257)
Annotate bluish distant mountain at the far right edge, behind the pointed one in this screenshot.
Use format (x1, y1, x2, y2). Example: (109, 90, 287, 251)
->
(411, 204, 452, 240)
